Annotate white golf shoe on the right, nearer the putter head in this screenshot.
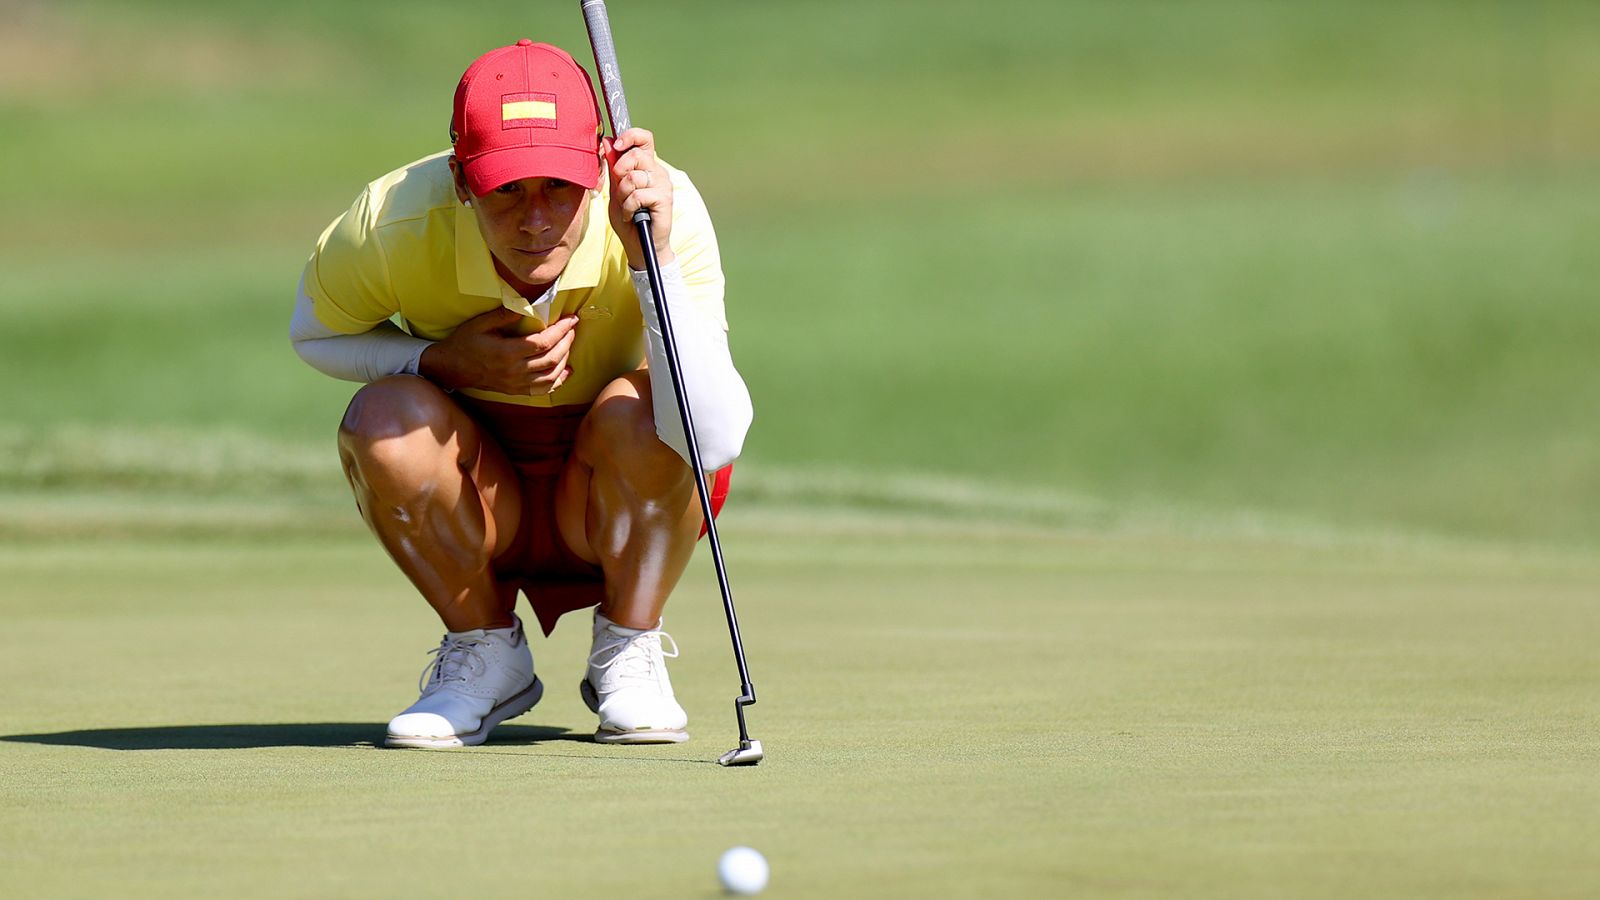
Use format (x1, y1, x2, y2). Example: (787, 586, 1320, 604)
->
(578, 612, 690, 743)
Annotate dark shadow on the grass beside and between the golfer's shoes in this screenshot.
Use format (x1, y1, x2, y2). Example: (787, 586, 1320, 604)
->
(0, 722, 592, 749)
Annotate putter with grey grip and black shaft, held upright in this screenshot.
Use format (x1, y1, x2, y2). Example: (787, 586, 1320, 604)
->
(579, 0, 763, 765)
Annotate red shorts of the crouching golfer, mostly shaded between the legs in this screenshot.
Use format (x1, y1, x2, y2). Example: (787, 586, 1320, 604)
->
(453, 394, 733, 634)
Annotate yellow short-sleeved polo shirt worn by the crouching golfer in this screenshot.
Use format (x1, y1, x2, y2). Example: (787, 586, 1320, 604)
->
(306, 151, 728, 407)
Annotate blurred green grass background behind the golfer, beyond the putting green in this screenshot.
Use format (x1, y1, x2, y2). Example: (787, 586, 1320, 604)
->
(0, 0, 1600, 544)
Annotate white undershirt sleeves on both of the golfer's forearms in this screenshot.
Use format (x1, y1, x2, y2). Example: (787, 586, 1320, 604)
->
(290, 261, 754, 472)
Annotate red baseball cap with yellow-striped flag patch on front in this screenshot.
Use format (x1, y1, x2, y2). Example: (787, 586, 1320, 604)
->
(450, 38, 600, 197)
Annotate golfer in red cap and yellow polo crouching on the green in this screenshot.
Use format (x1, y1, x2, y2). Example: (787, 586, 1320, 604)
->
(290, 40, 752, 748)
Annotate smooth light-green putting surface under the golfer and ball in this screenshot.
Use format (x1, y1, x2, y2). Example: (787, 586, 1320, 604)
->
(0, 504, 1600, 897)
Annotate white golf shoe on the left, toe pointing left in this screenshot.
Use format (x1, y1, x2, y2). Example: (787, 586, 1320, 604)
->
(384, 620, 544, 748)
